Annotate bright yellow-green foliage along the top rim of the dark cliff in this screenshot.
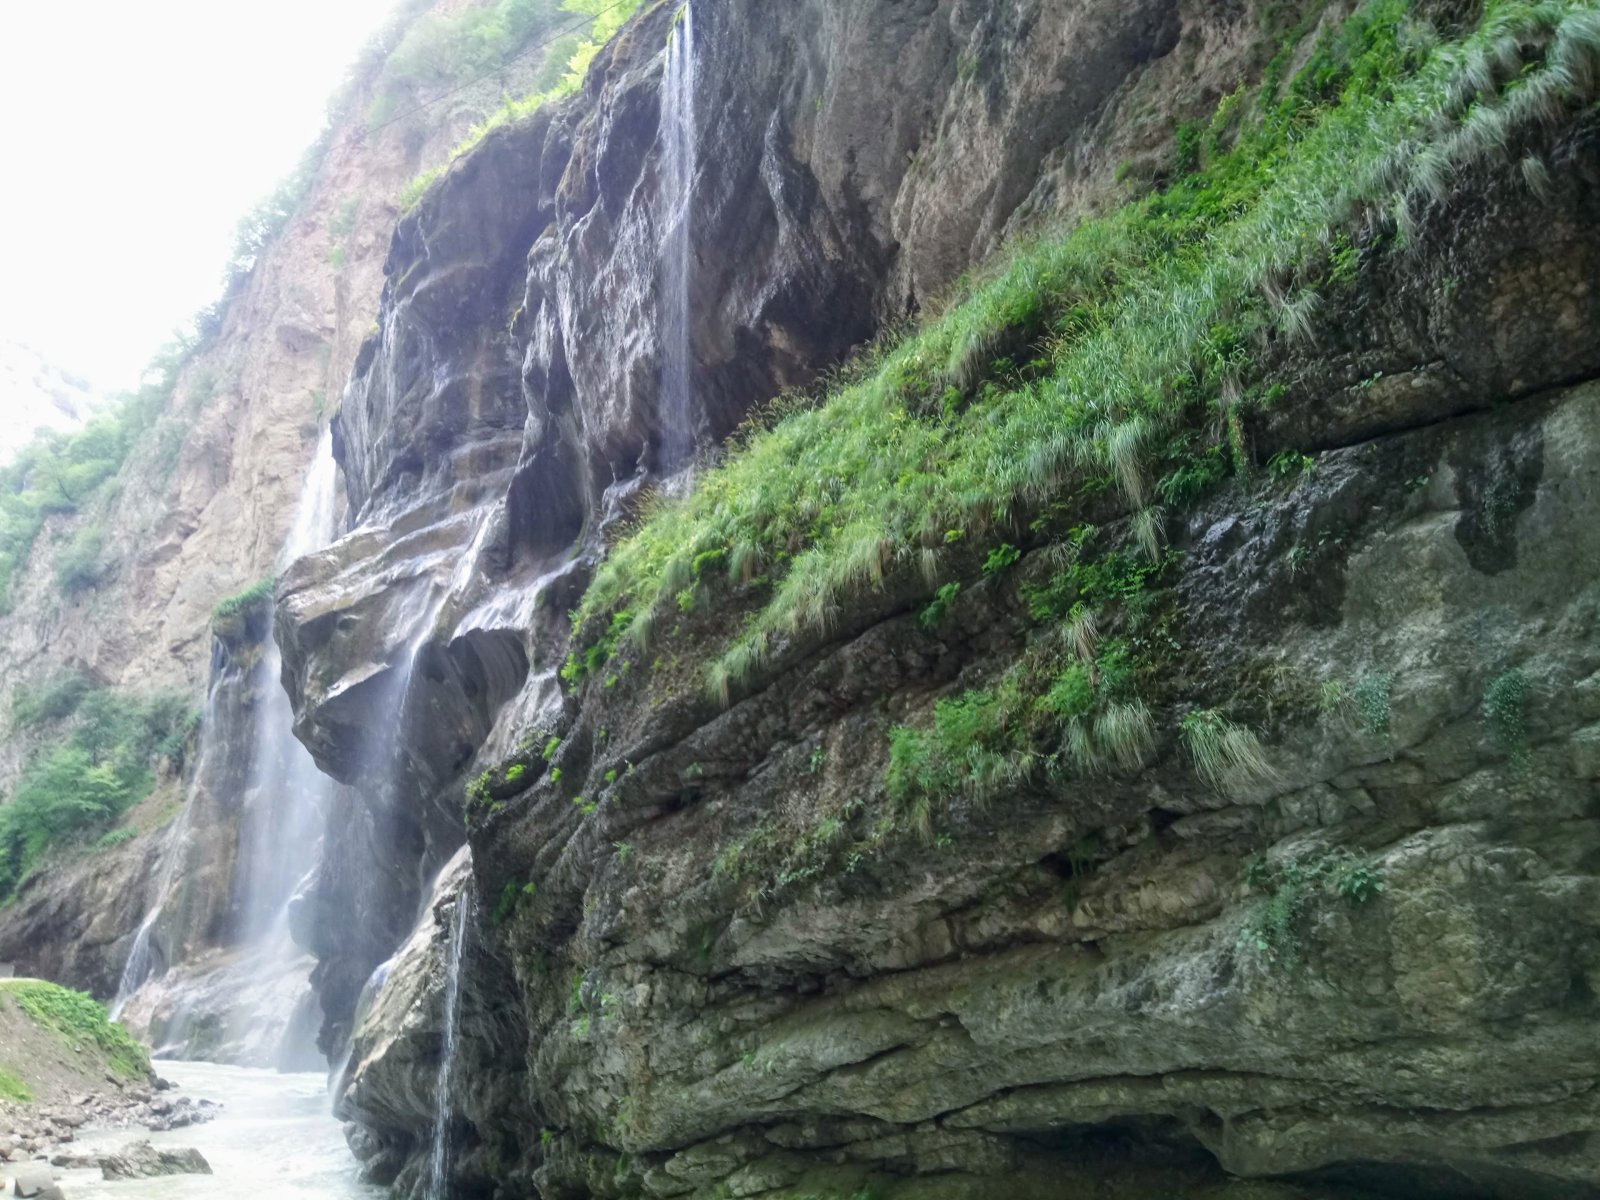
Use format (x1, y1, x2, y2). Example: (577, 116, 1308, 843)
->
(395, 0, 643, 211)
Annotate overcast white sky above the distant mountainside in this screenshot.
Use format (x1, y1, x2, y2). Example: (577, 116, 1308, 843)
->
(0, 0, 394, 390)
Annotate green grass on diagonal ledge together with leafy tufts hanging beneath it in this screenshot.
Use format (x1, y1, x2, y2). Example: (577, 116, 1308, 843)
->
(563, 0, 1600, 827)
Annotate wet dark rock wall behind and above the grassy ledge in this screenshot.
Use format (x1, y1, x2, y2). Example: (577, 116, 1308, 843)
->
(277, 2, 1286, 1068)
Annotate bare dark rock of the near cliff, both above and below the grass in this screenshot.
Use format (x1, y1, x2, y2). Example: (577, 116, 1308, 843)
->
(262, 0, 1600, 1200)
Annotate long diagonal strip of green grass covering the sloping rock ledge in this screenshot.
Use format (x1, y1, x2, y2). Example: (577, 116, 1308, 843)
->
(579, 0, 1600, 677)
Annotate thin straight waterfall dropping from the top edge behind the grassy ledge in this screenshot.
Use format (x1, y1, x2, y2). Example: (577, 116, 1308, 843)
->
(658, 3, 694, 475)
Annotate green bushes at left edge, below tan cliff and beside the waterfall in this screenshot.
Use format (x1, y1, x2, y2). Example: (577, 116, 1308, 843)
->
(0, 677, 198, 901)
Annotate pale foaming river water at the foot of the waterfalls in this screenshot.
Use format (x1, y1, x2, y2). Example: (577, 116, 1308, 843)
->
(61, 1062, 384, 1200)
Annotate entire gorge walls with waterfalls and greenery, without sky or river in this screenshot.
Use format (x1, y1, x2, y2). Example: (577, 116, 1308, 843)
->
(0, 0, 1600, 1200)
